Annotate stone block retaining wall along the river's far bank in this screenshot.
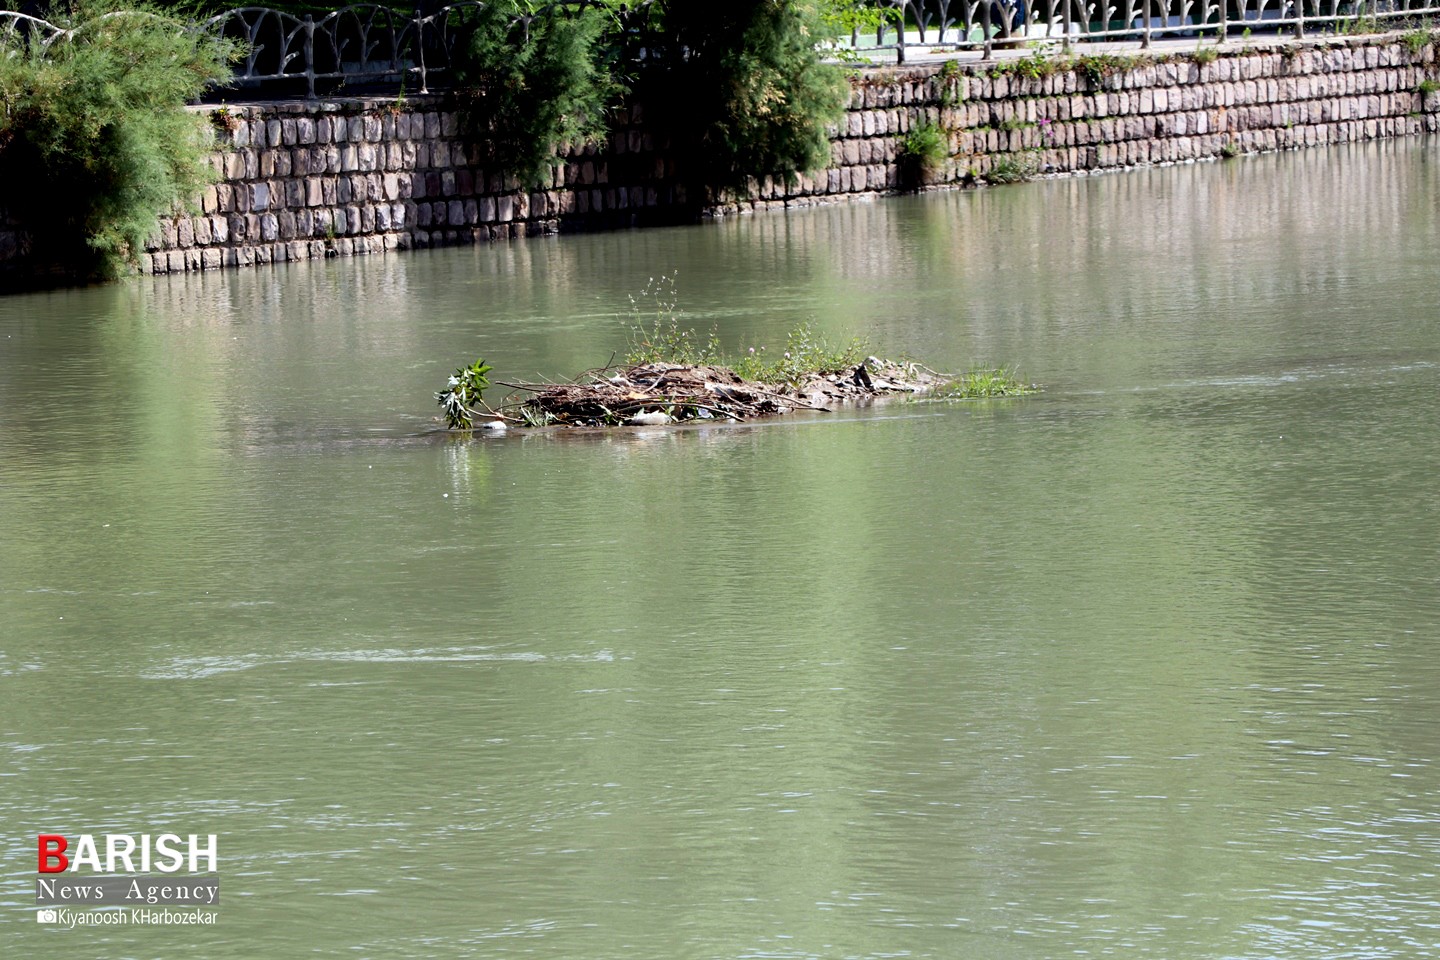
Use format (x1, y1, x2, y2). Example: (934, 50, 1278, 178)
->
(0, 36, 1440, 273)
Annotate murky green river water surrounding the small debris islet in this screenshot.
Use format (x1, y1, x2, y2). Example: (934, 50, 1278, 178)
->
(8, 142, 1440, 960)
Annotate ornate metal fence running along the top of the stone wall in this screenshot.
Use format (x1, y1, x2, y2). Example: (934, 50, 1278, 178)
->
(0, 0, 1440, 98)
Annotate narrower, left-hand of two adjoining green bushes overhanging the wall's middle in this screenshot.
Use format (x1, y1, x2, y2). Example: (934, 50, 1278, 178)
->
(454, 0, 622, 186)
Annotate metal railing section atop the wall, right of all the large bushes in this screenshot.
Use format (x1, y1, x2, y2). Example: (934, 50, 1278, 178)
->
(840, 0, 1440, 63)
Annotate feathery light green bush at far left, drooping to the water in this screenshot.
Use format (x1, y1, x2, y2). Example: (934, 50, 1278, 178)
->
(0, 0, 230, 276)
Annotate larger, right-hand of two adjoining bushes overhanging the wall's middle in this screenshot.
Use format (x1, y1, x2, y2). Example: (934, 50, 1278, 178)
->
(639, 0, 850, 192)
